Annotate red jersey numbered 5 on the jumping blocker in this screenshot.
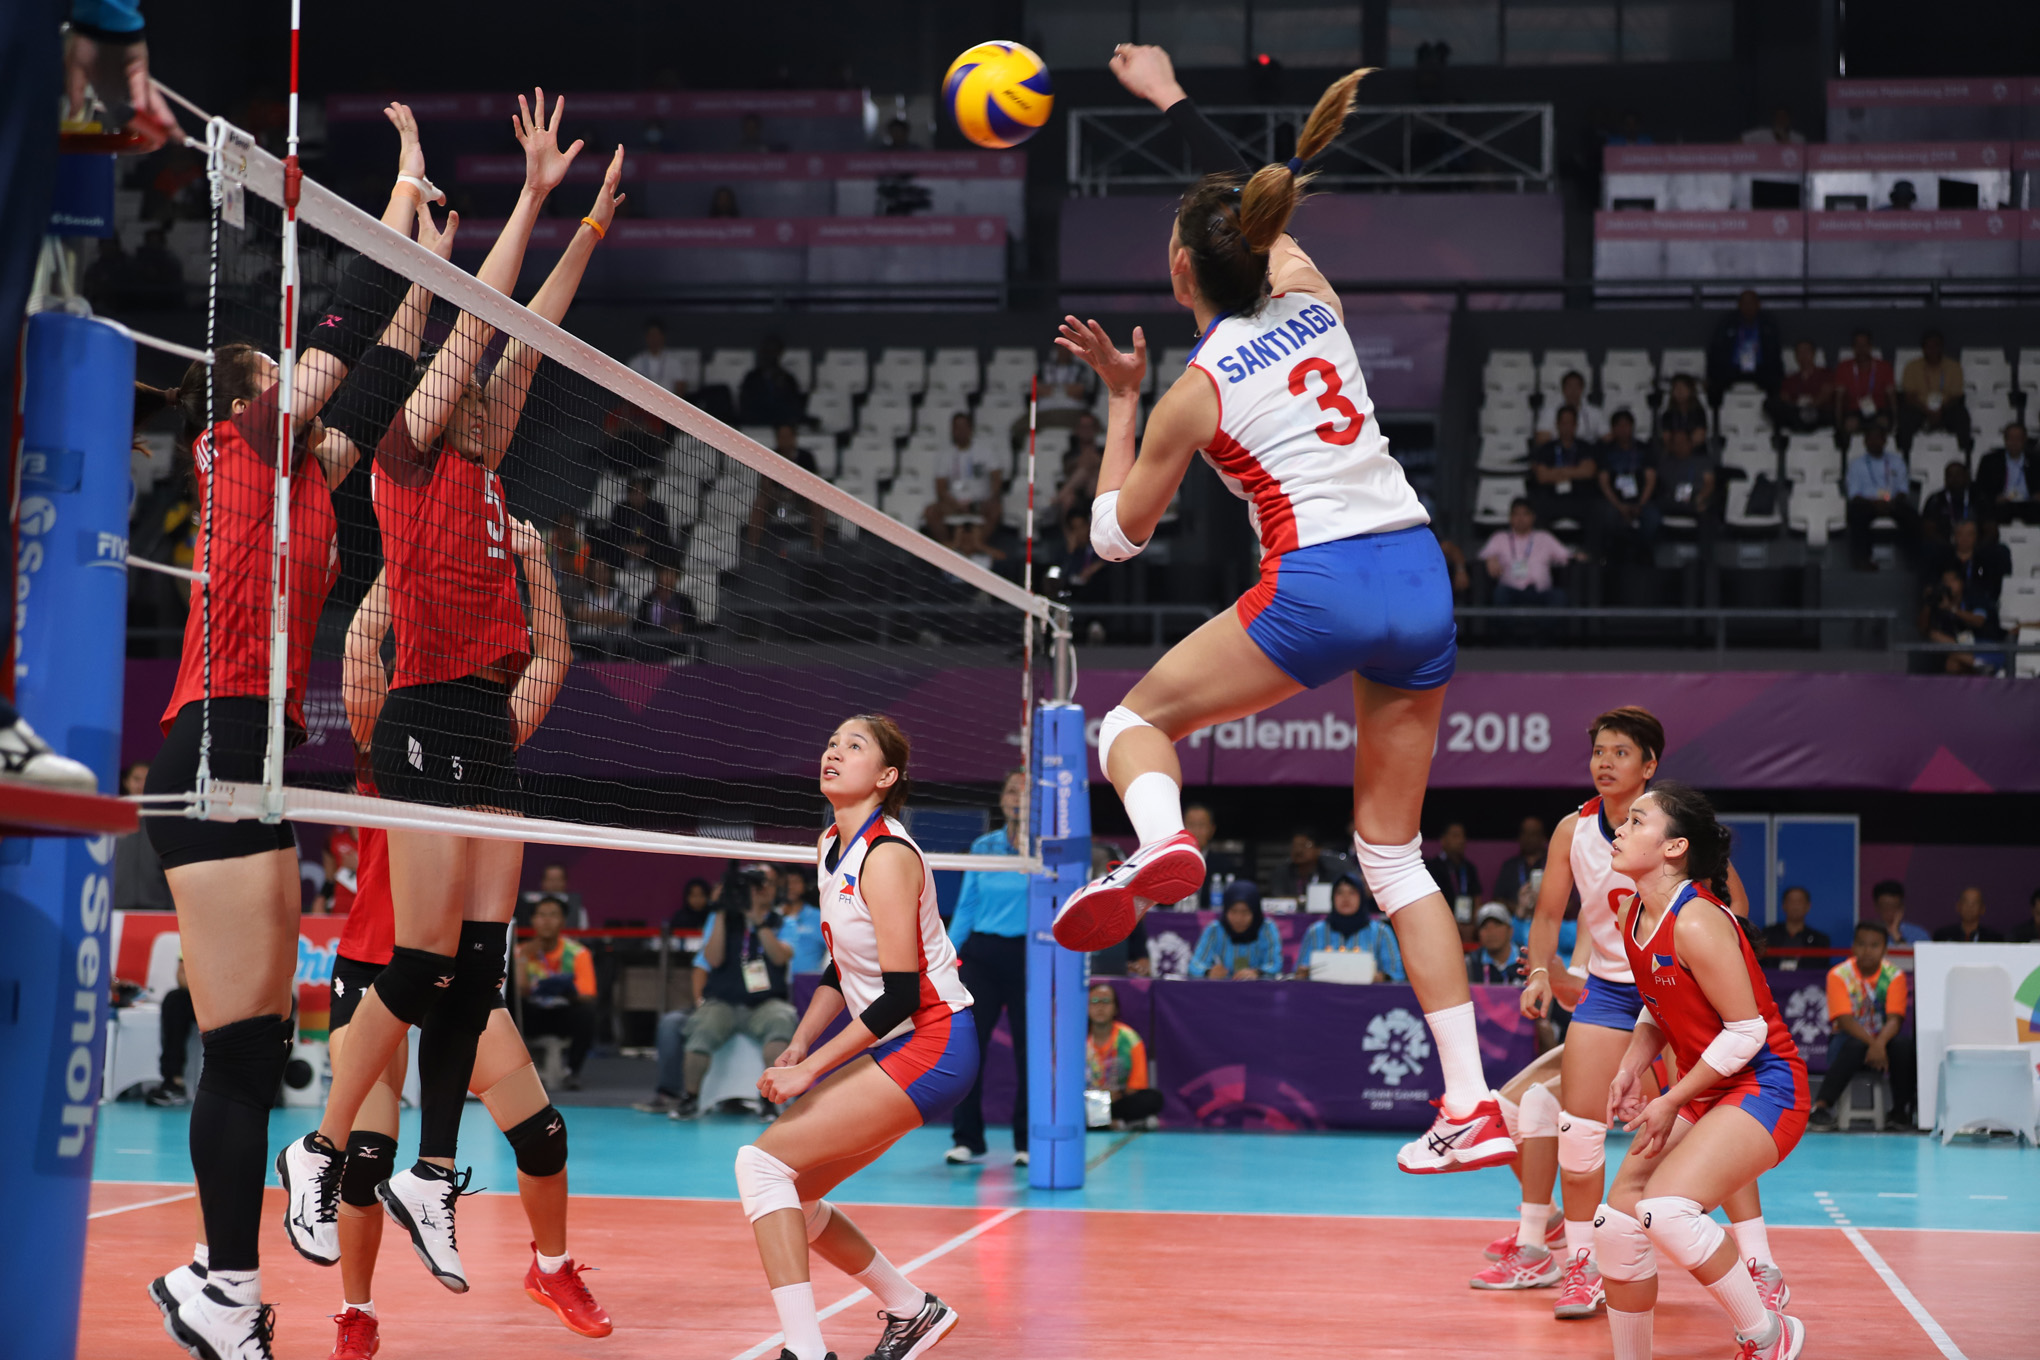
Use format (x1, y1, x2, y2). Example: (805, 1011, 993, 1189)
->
(373, 412, 530, 689)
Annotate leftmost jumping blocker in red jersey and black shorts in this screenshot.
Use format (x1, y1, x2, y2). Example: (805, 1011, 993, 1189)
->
(147, 104, 448, 1360)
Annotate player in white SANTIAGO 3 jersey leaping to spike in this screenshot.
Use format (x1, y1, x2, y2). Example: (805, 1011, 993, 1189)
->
(1055, 58, 1514, 1172)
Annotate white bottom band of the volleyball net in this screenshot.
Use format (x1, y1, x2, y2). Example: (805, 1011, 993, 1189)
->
(189, 779, 1042, 873)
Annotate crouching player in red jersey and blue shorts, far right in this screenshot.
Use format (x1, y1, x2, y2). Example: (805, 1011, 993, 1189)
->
(1593, 783, 1812, 1360)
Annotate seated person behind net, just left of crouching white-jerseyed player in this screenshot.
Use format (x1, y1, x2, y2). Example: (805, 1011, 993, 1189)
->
(673, 865, 800, 1119)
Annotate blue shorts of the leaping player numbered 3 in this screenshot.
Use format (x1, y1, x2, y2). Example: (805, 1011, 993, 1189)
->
(1234, 524, 1459, 689)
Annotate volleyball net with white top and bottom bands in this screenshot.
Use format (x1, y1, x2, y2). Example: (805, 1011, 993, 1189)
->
(173, 110, 1067, 869)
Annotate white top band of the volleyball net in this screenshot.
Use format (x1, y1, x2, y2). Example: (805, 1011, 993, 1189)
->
(215, 128, 1049, 620)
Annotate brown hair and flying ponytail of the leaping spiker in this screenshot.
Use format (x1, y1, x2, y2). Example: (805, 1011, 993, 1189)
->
(1175, 67, 1371, 316)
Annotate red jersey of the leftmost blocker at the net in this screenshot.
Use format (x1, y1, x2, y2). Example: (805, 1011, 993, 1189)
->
(161, 387, 341, 734)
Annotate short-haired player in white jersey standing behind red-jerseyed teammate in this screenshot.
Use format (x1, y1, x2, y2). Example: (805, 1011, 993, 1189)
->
(1514, 708, 1783, 1319)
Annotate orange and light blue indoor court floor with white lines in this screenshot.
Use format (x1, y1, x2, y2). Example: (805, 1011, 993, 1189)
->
(78, 1103, 2040, 1360)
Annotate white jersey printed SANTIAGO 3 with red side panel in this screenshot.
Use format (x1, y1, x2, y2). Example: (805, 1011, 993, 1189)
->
(1189, 294, 1430, 555)
